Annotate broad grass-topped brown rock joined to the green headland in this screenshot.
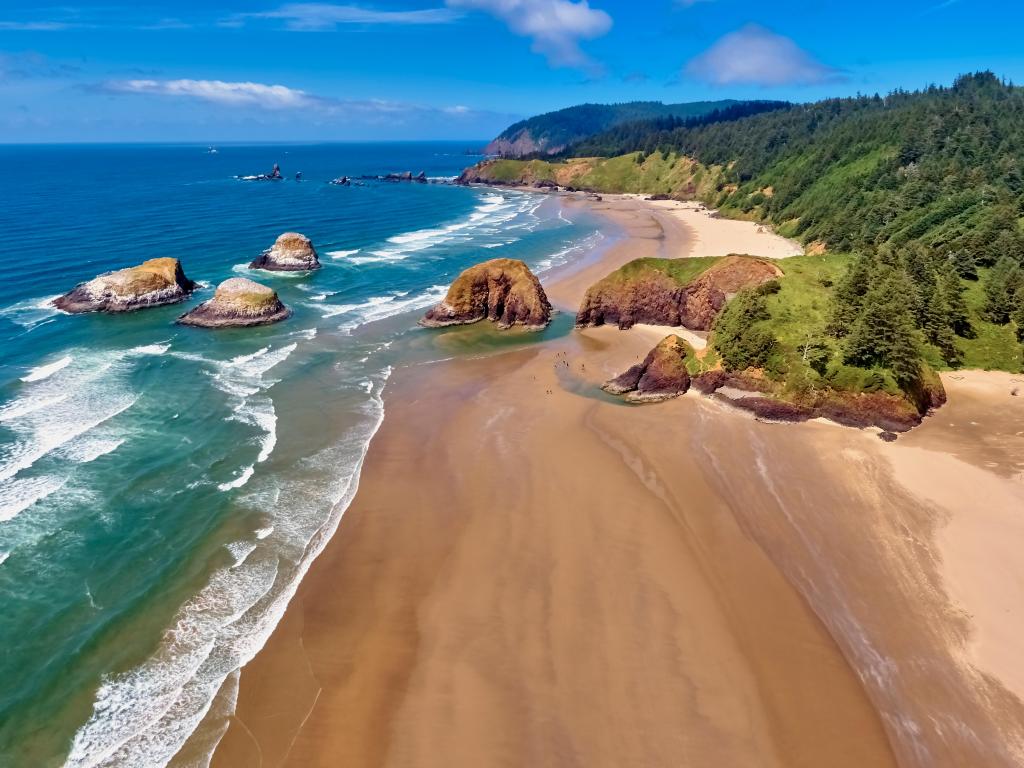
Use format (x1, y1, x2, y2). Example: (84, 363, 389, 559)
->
(577, 255, 782, 331)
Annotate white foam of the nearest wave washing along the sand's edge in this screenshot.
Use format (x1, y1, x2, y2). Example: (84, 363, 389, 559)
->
(66, 370, 390, 768)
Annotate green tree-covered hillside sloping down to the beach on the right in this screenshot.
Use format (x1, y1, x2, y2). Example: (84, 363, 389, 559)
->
(464, 73, 1024, 417)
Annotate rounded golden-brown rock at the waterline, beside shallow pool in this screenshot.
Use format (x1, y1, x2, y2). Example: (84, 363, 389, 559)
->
(420, 259, 551, 331)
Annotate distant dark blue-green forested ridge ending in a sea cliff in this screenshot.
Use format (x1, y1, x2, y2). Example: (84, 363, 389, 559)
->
(485, 99, 788, 158)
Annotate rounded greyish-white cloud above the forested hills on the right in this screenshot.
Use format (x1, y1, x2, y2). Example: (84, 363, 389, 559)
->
(685, 24, 842, 86)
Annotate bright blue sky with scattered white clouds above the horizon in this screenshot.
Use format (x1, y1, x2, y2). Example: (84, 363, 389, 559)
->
(0, 0, 1024, 143)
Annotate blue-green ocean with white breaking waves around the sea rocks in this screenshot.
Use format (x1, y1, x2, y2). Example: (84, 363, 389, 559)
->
(0, 143, 605, 768)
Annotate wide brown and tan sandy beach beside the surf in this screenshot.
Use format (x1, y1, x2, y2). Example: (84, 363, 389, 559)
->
(201, 197, 1024, 768)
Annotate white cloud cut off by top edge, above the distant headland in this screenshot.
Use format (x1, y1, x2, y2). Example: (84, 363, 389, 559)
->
(446, 0, 611, 70)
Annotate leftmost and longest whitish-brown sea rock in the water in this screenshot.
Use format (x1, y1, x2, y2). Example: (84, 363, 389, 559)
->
(53, 258, 196, 313)
